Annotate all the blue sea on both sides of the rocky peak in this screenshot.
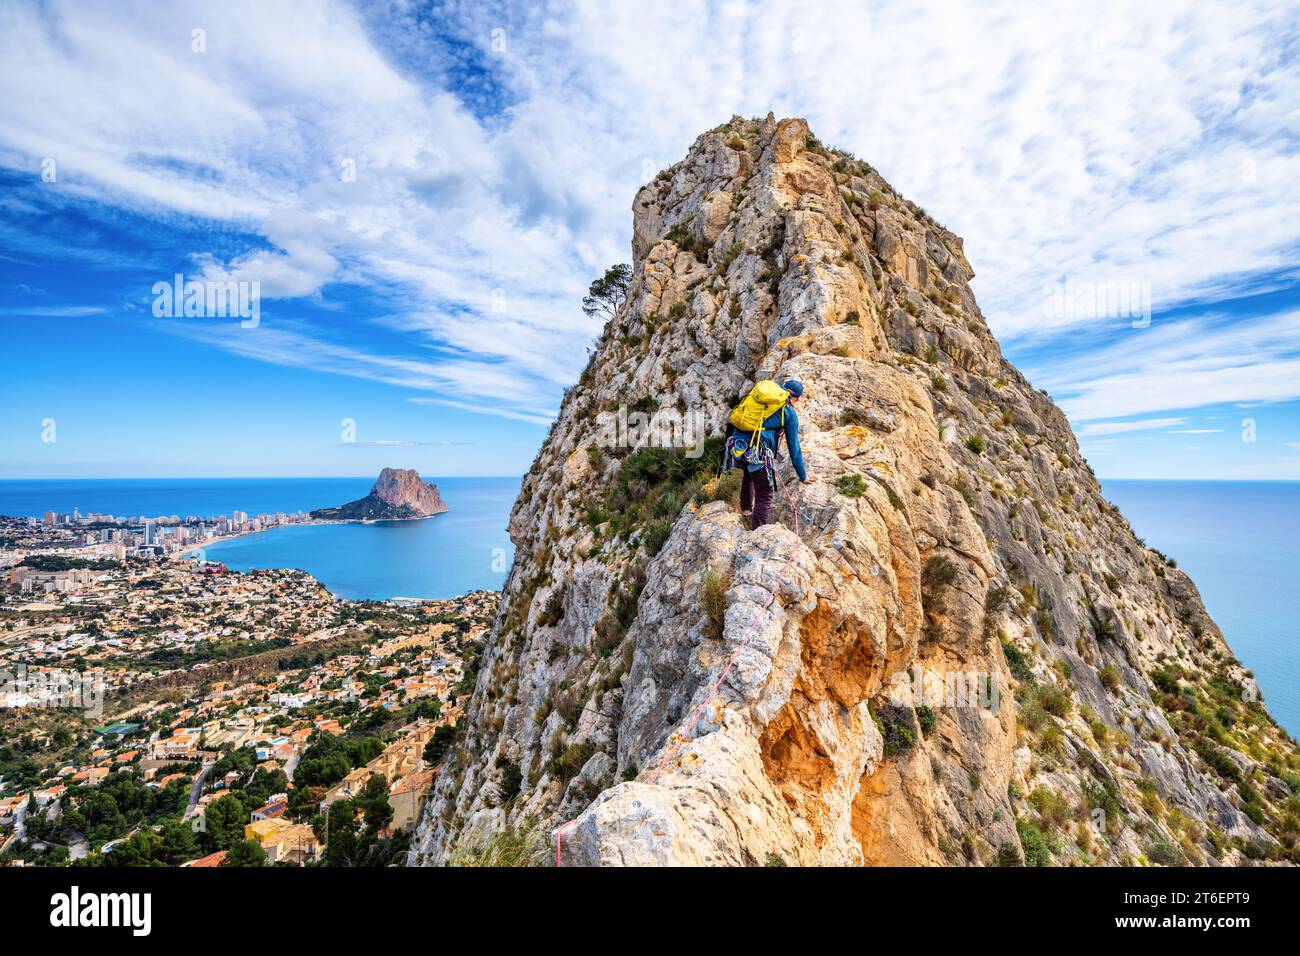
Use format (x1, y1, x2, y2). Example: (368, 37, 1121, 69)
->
(0, 477, 1300, 736)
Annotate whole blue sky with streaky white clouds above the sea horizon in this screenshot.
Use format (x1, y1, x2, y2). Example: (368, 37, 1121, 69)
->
(0, 0, 1300, 479)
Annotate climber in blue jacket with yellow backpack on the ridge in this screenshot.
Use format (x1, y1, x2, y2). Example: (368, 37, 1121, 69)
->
(727, 378, 816, 531)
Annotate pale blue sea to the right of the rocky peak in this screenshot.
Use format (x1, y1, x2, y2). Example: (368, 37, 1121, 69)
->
(1101, 480, 1300, 736)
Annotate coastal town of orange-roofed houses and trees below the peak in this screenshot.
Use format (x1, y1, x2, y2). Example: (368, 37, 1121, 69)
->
(0, 512, 498, 866)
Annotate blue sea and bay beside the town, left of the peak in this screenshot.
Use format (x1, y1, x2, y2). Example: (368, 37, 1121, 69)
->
(0, 477, 520, 598)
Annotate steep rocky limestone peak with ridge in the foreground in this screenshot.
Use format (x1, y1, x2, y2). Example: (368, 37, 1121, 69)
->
(410, 116, 1300, 865)
